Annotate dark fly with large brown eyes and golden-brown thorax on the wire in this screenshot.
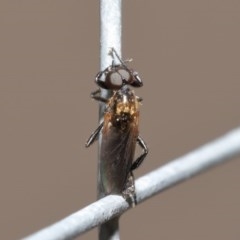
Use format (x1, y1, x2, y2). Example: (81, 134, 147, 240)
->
(86, 48, 148, 206)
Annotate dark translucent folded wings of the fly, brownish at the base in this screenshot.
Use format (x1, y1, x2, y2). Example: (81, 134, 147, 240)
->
(100, 114, 138, 195)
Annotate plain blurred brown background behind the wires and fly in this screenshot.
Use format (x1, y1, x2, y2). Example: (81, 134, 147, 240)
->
(0, 0, 240, 240)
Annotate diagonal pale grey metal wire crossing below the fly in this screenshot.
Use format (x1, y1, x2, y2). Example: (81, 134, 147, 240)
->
(23, 127, 240, 240)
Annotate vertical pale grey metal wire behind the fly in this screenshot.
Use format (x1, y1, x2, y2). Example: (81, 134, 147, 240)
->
(98, 0, 122, 240)
